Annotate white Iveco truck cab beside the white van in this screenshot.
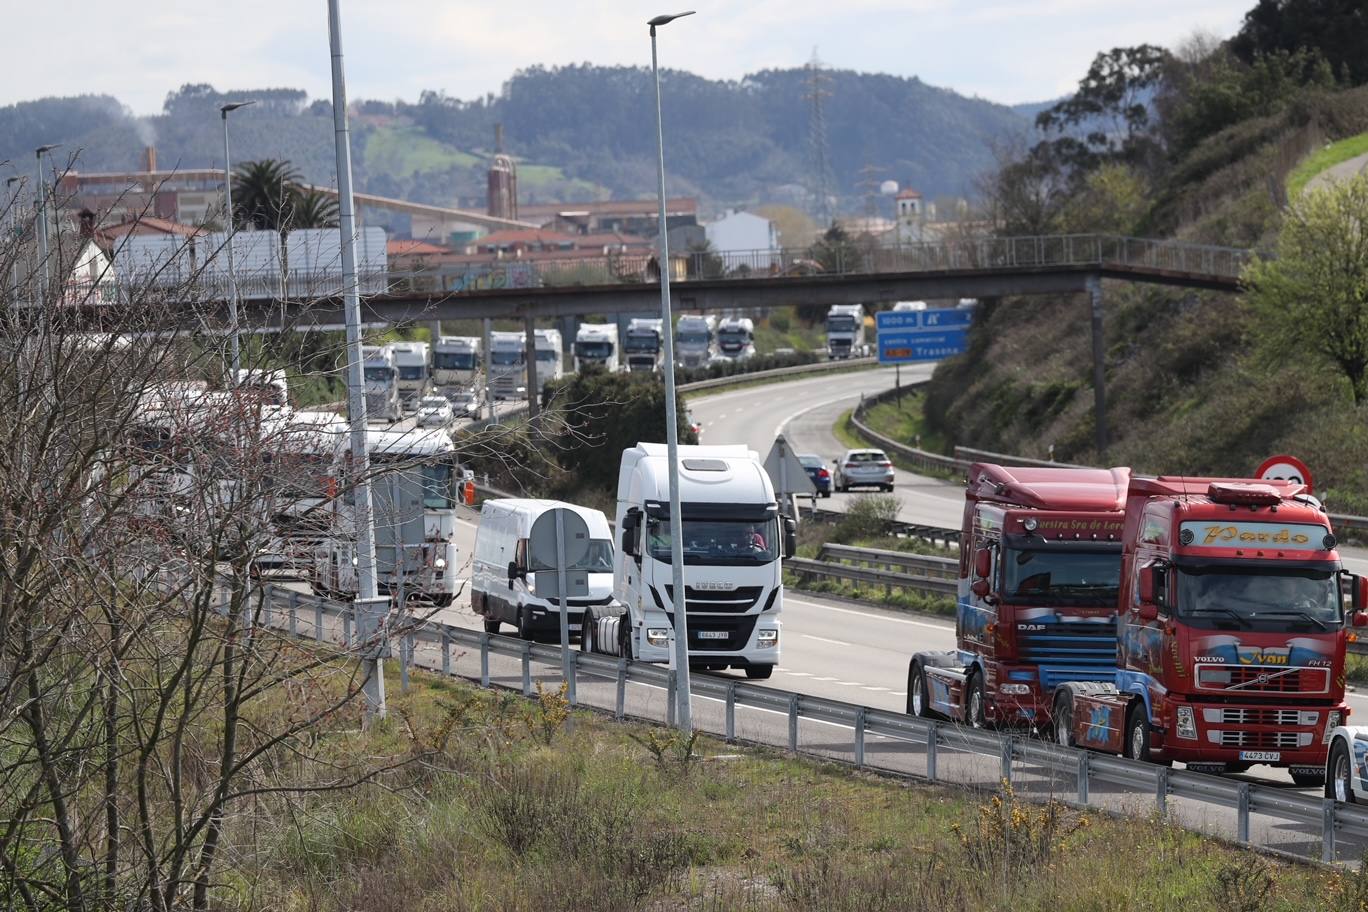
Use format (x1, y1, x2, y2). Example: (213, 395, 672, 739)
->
(580, 443, 795, 678)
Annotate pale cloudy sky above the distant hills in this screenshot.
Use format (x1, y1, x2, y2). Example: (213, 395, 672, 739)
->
(0, 0, 1253, 113)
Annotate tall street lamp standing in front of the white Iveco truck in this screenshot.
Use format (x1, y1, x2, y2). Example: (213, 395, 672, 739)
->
(646, 10, 694, 732)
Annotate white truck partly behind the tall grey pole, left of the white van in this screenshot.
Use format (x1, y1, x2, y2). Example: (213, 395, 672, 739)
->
(309, 429, 461, 607)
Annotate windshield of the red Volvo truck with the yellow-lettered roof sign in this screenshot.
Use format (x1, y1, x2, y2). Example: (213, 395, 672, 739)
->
(1176, 565, 1342, 629)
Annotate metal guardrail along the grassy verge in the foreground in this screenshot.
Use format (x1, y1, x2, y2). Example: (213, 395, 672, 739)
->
(254, 587, 1368, 863)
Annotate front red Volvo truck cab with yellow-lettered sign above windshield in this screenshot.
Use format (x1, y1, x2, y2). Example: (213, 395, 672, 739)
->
(1051, 477, 1363, 786)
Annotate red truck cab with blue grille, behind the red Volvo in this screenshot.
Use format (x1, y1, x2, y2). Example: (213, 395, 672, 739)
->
(907, 464, 1130, 730)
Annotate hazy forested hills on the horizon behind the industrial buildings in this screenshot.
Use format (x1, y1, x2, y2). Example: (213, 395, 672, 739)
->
(0, 66, 1030, 211)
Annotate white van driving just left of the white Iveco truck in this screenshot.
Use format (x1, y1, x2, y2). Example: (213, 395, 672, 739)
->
(471, 498, 613, 640)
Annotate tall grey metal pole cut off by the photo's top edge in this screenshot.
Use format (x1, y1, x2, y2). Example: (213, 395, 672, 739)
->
(328, 0, 391, 719)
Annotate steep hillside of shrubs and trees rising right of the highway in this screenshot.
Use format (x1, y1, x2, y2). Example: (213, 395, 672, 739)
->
(925, 10, 1368, 513)
